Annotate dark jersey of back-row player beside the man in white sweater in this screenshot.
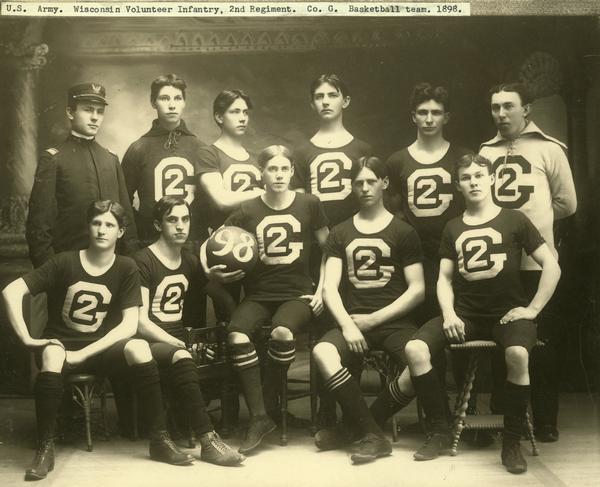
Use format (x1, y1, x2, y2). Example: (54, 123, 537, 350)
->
(387, 144, 471, 260)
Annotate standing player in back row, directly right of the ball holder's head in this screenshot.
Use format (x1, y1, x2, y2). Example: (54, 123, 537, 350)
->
(291, 74, 372, 426)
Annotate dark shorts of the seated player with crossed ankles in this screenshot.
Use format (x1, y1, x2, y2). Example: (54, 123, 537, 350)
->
(319, 318, 417, 370)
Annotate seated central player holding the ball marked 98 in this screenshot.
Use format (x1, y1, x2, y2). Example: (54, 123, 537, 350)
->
(202, 145, 329, 453)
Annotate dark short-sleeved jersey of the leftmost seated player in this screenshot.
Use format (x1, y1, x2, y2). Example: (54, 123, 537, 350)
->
(23, 251, 142, 341)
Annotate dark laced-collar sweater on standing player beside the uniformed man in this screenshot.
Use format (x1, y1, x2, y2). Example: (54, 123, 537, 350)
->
(123, 120, 206, 242)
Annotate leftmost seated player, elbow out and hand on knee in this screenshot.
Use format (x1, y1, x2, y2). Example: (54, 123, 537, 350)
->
(2, 200, 193, 480)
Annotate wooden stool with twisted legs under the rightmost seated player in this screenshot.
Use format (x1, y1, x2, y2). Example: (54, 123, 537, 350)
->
(450, 340, 539, 456)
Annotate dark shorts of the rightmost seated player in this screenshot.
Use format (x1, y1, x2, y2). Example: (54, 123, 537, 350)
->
(412, 315, 537, 356)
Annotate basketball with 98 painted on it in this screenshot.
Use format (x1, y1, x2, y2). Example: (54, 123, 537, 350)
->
(206, 226, 258, 272)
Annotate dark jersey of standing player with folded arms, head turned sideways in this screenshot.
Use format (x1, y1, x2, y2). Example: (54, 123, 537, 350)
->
(197, 145, 261, 230)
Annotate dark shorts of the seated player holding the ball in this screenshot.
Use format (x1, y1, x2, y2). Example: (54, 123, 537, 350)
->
(227, 299, 312, 336)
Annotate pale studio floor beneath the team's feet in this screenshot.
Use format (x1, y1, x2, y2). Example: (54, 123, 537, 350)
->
(0, 362, 600, 487)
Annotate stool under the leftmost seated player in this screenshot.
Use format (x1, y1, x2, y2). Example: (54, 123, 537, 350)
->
(65, 374, 109, 451)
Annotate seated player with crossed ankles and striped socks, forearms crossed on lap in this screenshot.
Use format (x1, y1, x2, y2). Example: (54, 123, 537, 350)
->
(313, 157, 425, 463)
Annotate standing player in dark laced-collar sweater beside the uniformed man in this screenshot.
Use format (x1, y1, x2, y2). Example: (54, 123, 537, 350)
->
(123, 74, 206, 250)
